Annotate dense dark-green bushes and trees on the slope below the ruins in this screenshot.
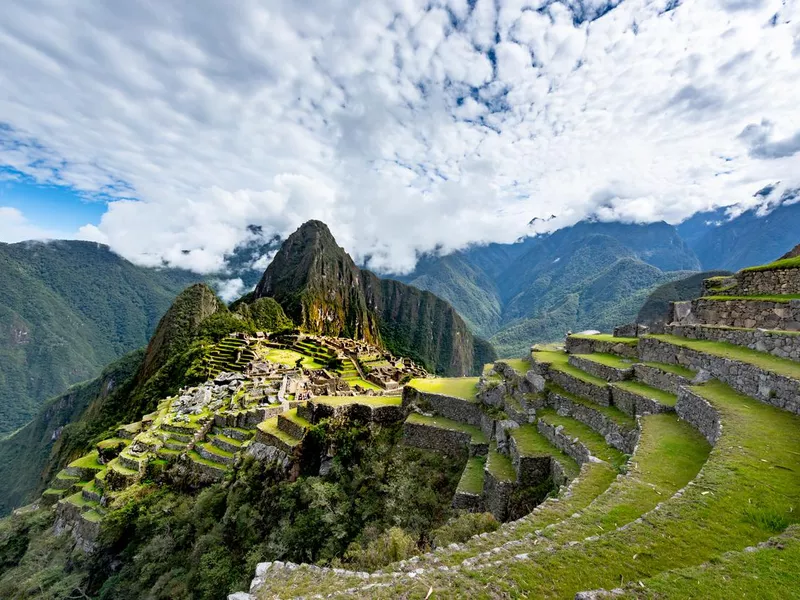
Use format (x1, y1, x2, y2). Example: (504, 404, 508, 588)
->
(0, 414, 482, 600)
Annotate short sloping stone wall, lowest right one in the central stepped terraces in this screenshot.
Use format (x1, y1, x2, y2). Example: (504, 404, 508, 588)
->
(547, 384, 639, 454)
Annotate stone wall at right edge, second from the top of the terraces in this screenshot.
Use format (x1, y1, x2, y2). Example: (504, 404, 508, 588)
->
(670, 298, 800, 331)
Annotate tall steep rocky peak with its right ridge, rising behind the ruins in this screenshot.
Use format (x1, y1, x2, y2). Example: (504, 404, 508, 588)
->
(252, 221, 493, 375)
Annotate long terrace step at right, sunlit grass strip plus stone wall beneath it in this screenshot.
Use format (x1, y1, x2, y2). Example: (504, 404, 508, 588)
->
(640, 335, 800, 414)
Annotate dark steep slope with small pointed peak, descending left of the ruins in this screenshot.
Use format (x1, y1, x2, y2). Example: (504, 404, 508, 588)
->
(0, 284, 228, 514)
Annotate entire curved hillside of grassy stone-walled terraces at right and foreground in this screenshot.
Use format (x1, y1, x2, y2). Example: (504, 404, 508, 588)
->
(236, 255, 800, 600)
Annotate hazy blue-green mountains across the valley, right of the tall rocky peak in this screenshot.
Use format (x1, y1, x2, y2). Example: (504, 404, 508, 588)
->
(400, 221, 700, 356)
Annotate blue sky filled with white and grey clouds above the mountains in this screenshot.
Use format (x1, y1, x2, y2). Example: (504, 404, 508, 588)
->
(0, 0, 800, 273)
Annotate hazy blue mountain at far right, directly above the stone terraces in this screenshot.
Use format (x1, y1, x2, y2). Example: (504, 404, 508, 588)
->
(678, 202, 800, 271)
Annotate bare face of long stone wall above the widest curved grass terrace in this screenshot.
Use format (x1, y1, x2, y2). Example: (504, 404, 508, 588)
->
(639, 338, 800, 414)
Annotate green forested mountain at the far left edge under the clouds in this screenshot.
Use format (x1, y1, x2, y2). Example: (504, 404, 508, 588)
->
(0, 241, 199, 434)
